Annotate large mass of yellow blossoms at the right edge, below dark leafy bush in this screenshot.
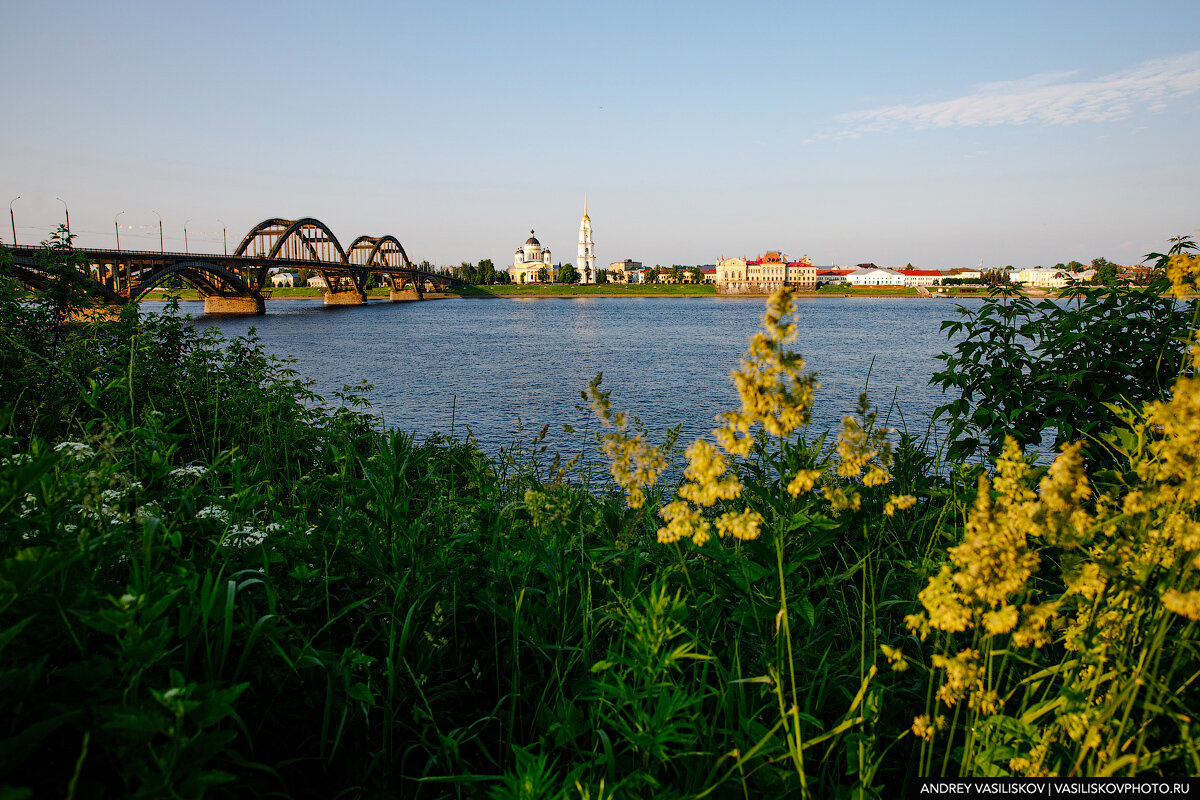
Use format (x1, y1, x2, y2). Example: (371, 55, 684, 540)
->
(906, 345, 1200, 775)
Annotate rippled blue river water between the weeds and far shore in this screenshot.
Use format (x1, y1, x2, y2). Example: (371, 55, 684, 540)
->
(143, 296, 980, 453)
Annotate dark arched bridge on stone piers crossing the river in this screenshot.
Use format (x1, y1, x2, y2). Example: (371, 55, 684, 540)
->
(8, 217, 461, 314)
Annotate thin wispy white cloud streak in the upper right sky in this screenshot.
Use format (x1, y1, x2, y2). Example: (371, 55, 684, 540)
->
(838, 52, 1200, 134)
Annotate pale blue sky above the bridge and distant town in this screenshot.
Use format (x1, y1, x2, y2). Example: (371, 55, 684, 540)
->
(0, 0, 1200, 269)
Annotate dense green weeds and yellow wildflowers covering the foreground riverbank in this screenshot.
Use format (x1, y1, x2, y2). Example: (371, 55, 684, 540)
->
(0, 234, 1200, 800)
